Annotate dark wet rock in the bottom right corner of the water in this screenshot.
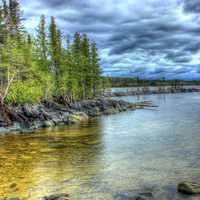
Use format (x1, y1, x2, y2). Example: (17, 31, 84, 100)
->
(177, 181, 200, 194)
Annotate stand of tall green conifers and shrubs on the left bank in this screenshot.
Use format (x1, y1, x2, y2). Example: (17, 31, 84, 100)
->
(0, 0, 108, 105)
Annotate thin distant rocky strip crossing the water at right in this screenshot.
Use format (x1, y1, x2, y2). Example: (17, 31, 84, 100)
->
(106, 87, 200, 97)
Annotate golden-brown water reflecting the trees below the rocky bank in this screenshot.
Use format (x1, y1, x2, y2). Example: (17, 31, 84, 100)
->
(0, 121, 106, 199)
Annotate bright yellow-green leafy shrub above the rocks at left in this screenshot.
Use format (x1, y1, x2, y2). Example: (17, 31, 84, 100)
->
(5, 80, 43, 104)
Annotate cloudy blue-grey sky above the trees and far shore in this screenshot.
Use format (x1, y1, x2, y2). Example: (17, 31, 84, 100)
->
(21, 0, 200, 79)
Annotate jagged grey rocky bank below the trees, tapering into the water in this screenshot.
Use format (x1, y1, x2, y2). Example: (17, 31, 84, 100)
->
(0, 98, 155, 133)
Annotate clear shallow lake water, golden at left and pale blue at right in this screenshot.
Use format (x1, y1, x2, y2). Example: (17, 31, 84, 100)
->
(0, 93, 200, 200)
